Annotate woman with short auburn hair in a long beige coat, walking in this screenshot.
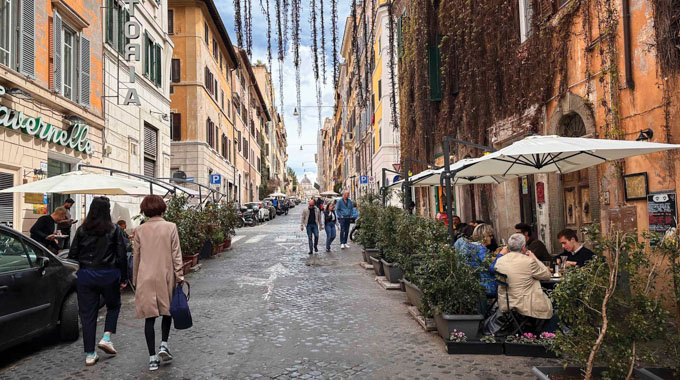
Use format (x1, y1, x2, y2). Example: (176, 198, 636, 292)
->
(133, 195, 184, 371)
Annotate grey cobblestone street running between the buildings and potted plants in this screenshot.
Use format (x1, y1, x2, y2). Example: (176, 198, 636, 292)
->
(0, 206, 556, 379)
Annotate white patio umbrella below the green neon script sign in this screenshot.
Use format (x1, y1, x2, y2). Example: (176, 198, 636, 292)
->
(0, 171, 163, 195)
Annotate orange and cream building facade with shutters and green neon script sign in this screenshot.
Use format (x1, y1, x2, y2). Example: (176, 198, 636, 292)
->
(0, 0, 105, 232)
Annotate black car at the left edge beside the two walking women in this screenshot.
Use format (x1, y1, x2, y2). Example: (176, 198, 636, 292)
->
(0, 225, 79, 351)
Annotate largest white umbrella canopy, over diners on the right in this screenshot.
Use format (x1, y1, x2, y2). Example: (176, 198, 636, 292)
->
(451, 136, 680, 178)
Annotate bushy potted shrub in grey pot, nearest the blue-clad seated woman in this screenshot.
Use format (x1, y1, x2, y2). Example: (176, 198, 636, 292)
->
(419, 244, 484, 339)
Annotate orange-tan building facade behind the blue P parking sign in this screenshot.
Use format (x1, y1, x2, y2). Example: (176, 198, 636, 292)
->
(168, 0, 242, 201)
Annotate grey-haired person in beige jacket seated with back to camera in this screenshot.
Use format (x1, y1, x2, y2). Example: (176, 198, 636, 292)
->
(495, 234, 553, 319)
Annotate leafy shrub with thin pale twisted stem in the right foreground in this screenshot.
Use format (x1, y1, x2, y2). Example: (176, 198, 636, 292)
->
(536, 226, 677, 379)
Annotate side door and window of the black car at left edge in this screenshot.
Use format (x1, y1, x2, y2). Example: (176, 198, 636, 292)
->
(0, 230, 51, 345)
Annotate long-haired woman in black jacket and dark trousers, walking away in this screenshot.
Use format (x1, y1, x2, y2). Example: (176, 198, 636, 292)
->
(68, 197, 127, 366)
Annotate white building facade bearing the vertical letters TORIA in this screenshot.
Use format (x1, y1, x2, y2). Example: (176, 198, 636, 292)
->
(102, 0, 174, 227)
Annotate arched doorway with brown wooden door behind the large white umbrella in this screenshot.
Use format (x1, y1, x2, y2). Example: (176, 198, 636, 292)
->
(559, 112, 593, 236)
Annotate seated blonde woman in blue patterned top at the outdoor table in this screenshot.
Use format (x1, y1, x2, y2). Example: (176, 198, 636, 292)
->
(453, 223, 502, 297)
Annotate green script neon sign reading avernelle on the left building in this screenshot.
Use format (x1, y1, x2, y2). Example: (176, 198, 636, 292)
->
(0, 86, 94, 155)
